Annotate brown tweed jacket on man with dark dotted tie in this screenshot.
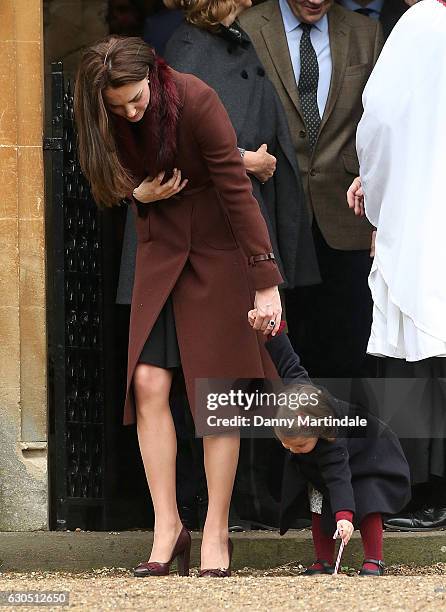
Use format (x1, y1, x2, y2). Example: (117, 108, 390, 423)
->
(240, 0, 383, 251)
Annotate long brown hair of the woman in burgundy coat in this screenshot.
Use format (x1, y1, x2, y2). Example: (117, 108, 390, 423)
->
(74, 36, 156, 206)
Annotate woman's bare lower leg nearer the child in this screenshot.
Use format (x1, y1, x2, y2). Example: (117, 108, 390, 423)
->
(201, 434, 240, 569)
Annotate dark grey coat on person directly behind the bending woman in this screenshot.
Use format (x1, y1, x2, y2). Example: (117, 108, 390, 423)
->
(165, 23, 320, 288)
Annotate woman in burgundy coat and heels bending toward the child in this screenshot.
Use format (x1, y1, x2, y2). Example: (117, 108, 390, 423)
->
(75, 37, 282, 576)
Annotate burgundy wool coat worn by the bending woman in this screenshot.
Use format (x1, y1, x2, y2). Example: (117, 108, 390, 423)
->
(116, 69, 283, 425)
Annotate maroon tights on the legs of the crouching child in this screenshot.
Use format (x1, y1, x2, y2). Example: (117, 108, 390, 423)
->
(311, 512, 383, 569)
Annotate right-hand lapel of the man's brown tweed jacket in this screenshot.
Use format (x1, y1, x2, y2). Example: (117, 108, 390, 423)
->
(320, 5, 350, 131)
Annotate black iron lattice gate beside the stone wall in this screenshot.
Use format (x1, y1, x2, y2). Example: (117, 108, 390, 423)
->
(44, 63, 107, 529)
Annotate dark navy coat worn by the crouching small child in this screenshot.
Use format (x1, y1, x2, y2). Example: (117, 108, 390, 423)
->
(266, 334, 411, 534)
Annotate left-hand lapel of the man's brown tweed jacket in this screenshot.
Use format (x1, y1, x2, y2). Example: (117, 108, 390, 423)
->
(261, 2, 303, 121)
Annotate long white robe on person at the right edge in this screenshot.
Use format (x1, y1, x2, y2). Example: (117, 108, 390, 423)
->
(356, 0, 446, 361)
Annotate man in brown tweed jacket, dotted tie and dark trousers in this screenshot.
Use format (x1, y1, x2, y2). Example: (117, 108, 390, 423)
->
(240, 0, 383, 377)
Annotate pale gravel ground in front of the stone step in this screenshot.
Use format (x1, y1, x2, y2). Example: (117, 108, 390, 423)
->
(0, 563, 446, 612)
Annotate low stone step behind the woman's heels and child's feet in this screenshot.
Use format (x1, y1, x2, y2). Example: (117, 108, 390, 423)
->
(0, 530, 446, 572)
